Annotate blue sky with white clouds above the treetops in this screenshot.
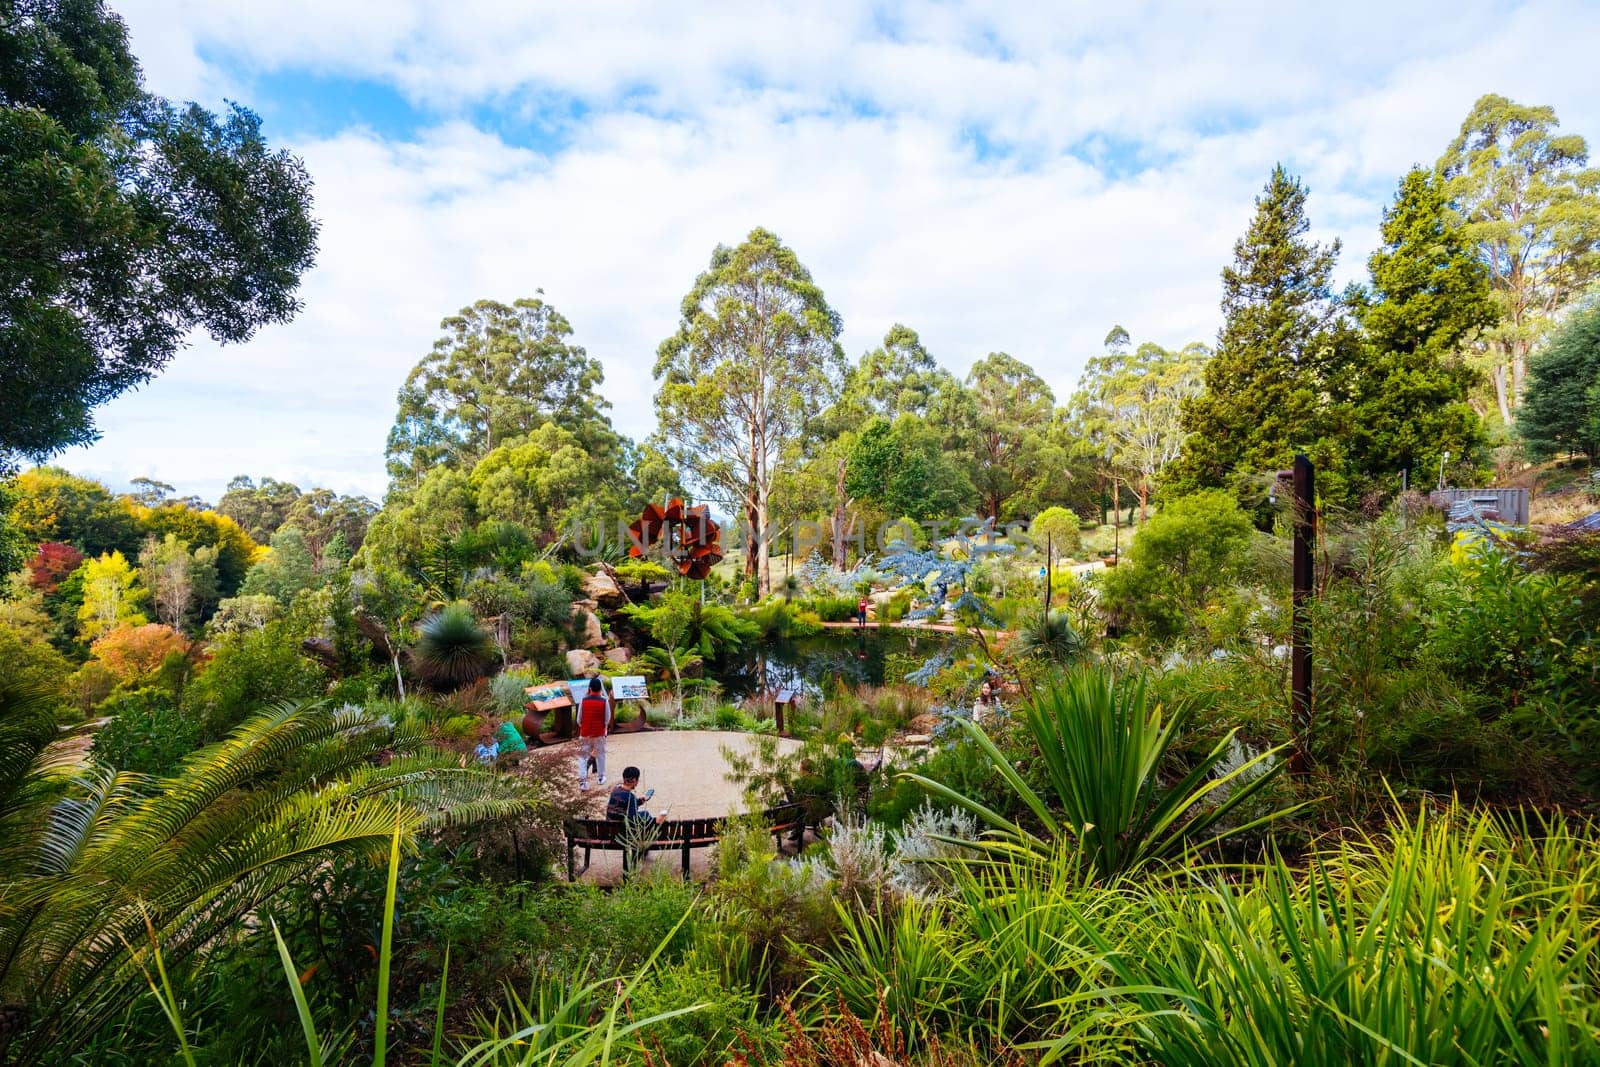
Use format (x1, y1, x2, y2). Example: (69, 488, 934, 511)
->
(54, 0, 1600, 501)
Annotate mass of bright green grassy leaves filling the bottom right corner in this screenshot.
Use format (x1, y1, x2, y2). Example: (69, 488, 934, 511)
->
(1048, 808, 1600, 1067)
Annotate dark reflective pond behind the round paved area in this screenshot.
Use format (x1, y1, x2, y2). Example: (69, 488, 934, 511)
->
(715, 625, 958, 701)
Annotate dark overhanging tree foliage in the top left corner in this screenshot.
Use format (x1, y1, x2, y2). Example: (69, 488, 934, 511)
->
(0, 0, 317, 462)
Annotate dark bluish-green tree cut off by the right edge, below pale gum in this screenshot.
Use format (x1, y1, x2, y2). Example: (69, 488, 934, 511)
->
(1517, 304, 1600, 459)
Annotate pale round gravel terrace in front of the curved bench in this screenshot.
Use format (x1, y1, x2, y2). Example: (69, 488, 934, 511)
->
(530, 729, 800, 885)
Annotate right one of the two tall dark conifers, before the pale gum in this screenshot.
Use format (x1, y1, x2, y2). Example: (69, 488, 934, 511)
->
(1341, 168, 1498, 488)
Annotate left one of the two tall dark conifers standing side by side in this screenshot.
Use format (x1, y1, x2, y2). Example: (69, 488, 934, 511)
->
(1163, 165, 1349, 498)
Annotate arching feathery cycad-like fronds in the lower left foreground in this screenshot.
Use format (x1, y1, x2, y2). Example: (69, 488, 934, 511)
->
(0, 704, 531, 1062)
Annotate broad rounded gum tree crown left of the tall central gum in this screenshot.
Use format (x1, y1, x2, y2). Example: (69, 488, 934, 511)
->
(387, 290, 621, 488)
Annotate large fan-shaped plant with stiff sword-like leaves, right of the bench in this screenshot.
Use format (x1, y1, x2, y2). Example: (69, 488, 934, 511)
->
(907, 667, 1288, 880)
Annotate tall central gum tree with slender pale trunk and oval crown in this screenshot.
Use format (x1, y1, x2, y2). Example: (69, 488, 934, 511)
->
(654, 229, 845, 595)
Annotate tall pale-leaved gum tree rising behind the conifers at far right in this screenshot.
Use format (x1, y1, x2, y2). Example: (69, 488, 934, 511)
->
(1437, 93, 1600, 426)
